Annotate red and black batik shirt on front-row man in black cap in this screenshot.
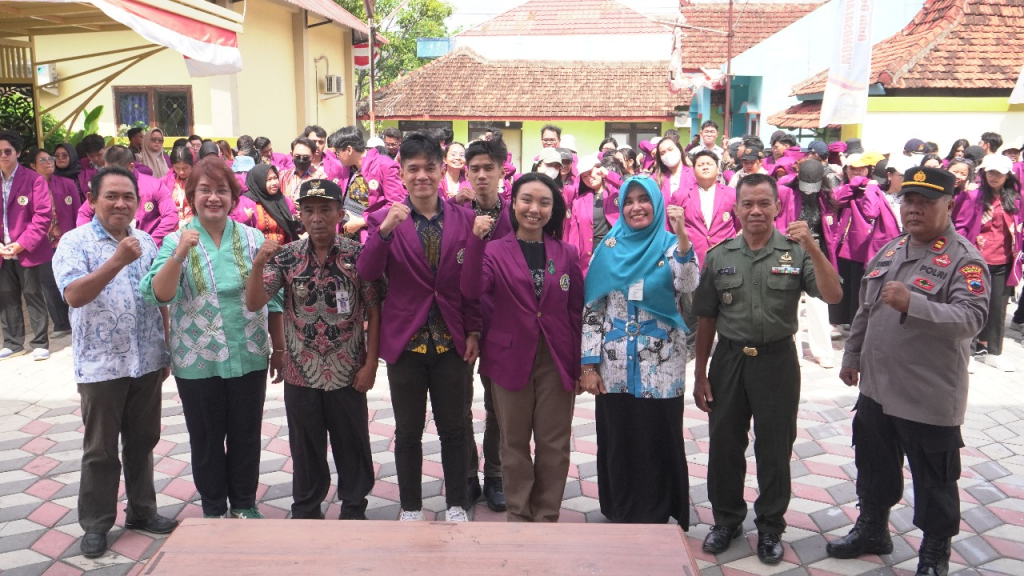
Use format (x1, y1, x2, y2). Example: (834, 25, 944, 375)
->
(263, 236, 386, 390)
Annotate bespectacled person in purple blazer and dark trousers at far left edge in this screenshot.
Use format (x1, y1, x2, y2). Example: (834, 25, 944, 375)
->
(0, 130, 54, 360)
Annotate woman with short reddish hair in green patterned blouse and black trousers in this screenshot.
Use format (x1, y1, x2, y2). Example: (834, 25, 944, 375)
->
(140, 157, 285, 518)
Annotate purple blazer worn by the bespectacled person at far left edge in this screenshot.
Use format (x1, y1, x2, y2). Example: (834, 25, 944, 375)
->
(0, 166, 53, 268)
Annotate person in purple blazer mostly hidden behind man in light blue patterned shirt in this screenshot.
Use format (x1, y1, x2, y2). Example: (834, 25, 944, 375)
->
(78, 146, 178, 248)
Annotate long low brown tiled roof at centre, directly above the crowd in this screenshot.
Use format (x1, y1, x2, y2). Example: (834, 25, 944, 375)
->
(357, 48, 692, 121)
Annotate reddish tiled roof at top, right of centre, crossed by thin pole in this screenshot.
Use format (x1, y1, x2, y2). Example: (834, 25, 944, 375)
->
(680, 0, 821, 69)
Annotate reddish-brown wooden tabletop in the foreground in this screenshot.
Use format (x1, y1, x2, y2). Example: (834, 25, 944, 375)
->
(141, 519, 700, 576)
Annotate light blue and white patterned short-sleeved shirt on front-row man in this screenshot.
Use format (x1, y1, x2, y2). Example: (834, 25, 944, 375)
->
(53, 218, 170, 383)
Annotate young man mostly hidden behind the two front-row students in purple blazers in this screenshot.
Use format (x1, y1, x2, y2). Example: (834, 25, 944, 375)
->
(449, 139, 512, 506)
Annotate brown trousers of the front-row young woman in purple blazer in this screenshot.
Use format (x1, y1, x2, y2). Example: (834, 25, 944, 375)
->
(492, 336, 575, 522)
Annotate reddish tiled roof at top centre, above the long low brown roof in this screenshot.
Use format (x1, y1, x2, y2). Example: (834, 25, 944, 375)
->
(459, 0, 669, 36)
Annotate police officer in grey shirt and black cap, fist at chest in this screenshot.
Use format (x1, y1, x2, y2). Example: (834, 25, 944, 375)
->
(825, 167, 989, 576)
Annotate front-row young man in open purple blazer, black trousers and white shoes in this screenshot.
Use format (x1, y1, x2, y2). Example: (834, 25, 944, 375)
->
(356, 134, 481, 522)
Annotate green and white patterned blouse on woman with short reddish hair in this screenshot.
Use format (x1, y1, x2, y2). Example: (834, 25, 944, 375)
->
(139, 218, 281, 379)
